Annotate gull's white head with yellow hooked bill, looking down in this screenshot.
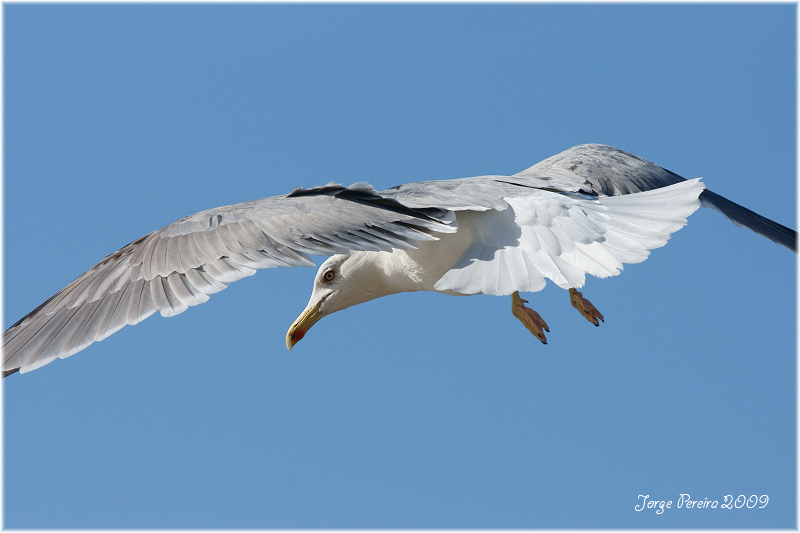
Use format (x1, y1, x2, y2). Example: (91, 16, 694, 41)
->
(286, 252, 398, 350)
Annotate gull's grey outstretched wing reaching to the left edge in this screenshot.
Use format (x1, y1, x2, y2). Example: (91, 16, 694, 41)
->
(3, 184, 456, 376)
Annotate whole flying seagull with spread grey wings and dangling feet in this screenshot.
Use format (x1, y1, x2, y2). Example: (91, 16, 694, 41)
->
(3, 144, 797, 376)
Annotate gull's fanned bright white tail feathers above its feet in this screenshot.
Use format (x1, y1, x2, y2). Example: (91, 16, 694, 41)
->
(435, 180, 703, 295)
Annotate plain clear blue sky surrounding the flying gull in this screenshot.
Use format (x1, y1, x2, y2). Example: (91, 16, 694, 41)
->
(3, 4, 796, 528)
